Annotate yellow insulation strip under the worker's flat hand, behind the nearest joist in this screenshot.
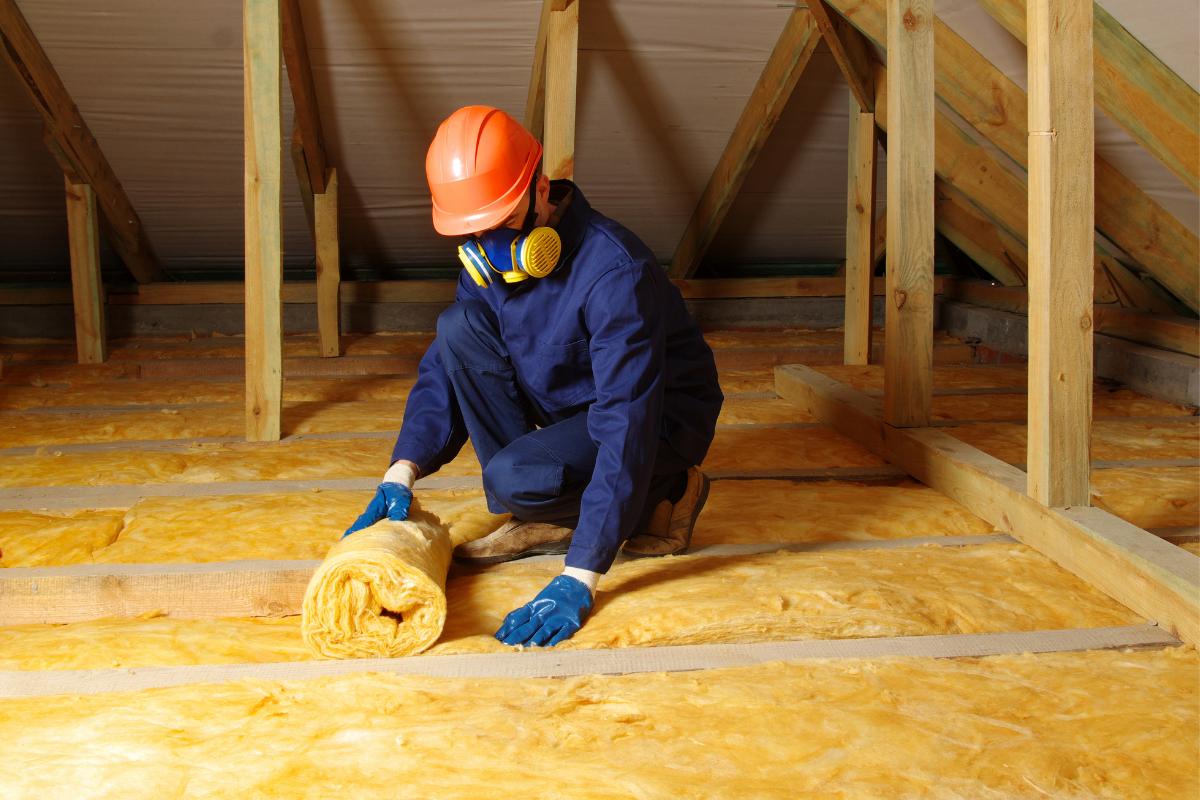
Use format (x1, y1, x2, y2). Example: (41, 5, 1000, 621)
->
(0, 545, 1140, 669)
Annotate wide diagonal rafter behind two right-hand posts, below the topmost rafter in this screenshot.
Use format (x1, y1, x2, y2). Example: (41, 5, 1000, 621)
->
(827, 0, 1200, 311)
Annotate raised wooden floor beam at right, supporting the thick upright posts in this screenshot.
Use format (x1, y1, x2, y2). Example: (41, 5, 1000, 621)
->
(775, 365, 1200, 644)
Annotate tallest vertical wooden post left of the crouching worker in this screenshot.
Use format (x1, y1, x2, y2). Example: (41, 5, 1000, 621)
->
(242, 0, 283, 441)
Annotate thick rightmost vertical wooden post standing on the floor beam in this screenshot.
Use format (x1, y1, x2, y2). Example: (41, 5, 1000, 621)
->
(1027, 0, 1096, 506)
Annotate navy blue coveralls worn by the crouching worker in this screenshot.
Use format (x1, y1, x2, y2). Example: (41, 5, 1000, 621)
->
(392, 181, 724, 572)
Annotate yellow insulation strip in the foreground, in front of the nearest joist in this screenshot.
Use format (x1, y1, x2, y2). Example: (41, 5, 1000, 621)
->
(0, 648, 1200, 800)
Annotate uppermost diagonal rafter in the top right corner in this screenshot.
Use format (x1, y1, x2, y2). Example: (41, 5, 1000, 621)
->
(979, 0, 1200, 192)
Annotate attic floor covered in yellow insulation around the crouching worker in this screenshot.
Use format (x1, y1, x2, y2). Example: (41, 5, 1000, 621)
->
(0, 331, 1200, 798)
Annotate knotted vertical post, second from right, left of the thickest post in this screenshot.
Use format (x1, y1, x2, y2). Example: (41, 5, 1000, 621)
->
(883, 0, 934, 427)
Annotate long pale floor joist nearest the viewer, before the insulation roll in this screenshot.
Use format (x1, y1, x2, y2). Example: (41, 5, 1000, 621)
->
(0, 625, 1178, 698)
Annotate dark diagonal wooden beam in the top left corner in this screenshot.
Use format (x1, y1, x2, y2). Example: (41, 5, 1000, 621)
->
(0, 0, 167, 283)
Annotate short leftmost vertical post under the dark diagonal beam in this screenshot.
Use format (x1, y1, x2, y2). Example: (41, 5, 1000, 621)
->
(64, 179, 108, 363)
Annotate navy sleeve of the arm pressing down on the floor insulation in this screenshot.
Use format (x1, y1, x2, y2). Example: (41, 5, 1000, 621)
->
(566, 263, 666, 572)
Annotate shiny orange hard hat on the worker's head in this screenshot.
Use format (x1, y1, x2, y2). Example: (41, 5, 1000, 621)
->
(425, 106, 541, 236)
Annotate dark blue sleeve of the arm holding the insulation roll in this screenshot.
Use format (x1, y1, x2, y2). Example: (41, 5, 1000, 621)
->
(391, 270, 474, 475)
